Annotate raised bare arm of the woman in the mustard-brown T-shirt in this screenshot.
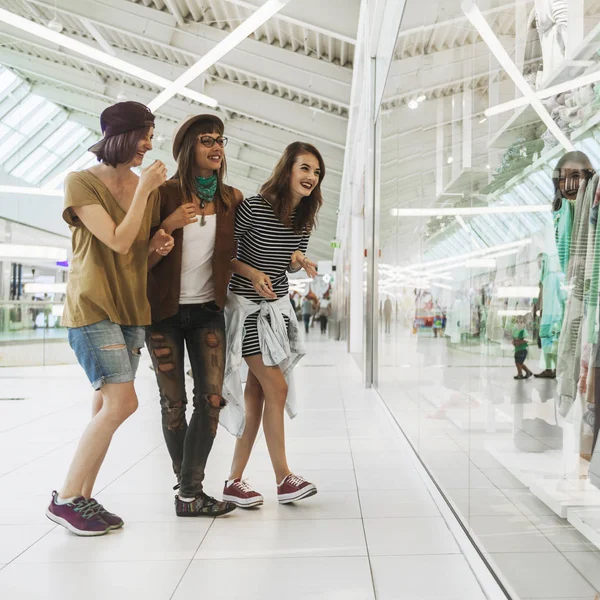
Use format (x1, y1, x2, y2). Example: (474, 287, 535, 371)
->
(71, 160, 167, 254)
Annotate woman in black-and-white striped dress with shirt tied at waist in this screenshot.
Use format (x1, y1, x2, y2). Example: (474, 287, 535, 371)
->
(221, 142, 325, 507)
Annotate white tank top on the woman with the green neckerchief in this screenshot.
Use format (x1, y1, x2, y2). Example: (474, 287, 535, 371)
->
(179, 215, 217, 304)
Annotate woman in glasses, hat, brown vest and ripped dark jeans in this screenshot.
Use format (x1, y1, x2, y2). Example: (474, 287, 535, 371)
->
(147, 115, 243, 517)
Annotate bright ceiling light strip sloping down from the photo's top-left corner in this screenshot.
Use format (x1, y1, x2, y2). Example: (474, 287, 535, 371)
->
(0, 8, 218, 108)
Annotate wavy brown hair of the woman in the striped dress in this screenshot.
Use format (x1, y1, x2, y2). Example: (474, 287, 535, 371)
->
(260, 142, 325, 233)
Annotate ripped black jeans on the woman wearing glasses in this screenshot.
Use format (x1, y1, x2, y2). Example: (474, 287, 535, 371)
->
(146, 302, 225, 498)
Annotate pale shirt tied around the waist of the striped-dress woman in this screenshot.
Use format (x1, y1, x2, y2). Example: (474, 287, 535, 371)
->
(219, 292, 306, 437)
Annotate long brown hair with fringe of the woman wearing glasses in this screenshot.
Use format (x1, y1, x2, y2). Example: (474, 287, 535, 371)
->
(173, 119, 233, 213)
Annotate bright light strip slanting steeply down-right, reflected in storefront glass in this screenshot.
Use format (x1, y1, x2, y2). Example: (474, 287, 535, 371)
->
(461, 0, 575, 151)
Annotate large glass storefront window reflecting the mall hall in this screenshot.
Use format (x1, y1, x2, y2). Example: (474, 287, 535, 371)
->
(374, 0, 600, 600)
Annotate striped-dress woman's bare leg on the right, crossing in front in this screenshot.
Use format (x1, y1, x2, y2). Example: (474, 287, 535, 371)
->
(246, 354, 290, 483)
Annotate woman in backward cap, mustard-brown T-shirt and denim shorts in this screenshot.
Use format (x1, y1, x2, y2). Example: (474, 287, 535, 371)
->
(46, 102, 173, 536)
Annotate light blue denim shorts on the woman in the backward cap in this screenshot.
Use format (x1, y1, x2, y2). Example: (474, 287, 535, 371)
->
(69, 320, 146, 390)
